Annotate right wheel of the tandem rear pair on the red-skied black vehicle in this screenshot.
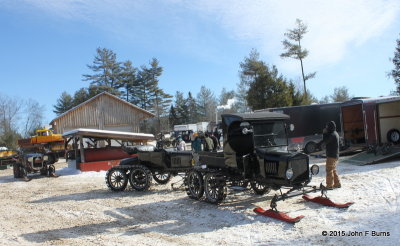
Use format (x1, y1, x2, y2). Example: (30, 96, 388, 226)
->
(204, 173, 226, 204)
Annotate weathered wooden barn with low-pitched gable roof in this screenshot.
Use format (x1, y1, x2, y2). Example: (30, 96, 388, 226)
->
(50, 92, 154, 134)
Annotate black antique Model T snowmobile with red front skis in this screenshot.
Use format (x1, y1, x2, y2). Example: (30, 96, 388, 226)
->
(185, 112, 349, 223)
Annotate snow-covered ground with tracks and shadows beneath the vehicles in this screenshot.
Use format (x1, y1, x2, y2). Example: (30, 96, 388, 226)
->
(0, 159, 400, 246)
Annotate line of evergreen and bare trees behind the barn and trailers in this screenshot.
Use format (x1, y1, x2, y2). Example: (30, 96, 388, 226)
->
(54, 19, 400, 136)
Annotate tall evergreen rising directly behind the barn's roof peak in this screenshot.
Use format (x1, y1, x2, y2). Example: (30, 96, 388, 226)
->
(83, 48, 121, 89)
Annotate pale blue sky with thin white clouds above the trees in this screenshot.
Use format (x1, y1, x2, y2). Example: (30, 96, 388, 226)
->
(0, 0, 400, 122)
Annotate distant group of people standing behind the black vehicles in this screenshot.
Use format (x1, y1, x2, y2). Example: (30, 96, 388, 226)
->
(176, 131, 221, 152)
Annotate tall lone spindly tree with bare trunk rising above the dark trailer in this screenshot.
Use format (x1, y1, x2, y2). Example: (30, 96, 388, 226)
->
(281, 19, 316, 96)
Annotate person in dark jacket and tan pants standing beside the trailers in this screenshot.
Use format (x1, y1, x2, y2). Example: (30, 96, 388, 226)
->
(317, 121, 342, 189)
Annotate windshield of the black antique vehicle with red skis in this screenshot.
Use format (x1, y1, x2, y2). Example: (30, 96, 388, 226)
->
(252, 122, 287, 148)
